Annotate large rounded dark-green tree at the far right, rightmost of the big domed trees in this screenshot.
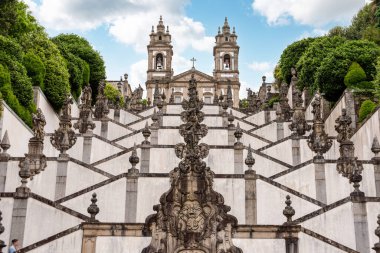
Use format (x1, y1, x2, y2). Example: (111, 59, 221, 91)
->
(315, 40, 380, 101)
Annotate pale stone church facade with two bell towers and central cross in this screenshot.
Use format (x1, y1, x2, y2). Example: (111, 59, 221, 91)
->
(145, 17, 240, 107)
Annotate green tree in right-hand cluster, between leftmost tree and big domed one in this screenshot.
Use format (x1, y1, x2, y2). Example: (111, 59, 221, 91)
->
(296, 36, 345, 91)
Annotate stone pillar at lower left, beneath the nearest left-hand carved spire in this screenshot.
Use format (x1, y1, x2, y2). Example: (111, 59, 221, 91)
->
(9, 197, 28, 246)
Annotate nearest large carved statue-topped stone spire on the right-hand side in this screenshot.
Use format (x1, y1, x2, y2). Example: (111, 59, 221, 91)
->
(335, 109, 363, 180)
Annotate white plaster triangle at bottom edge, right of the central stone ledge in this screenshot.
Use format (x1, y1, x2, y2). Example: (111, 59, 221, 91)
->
(298, 232, 346, 253)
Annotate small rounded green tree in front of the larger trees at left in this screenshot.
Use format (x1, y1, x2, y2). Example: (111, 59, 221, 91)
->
(23, 52, 46, 89)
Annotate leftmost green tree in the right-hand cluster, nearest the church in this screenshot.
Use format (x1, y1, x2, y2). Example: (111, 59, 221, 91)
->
(279, 38, 315, 83)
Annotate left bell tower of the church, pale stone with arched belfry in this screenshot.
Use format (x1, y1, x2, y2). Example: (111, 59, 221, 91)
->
(146, 16, 173, 101)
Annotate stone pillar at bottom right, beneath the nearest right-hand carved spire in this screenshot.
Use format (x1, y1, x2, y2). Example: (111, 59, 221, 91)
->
(352, 197, 370, 253)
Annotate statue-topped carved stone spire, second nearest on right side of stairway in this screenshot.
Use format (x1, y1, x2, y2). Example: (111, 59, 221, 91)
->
(307, 92, 332, 162)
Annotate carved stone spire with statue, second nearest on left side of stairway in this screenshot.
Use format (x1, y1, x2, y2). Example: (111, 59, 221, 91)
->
(50, 95, 77, 157)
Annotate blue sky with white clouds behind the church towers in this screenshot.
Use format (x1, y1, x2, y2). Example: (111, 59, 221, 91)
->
(24, 0, 369, 96)
